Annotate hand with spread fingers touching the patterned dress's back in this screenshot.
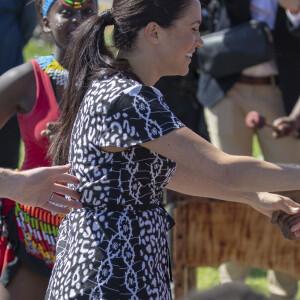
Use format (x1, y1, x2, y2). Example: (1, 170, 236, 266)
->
(11, 164, 82, 214)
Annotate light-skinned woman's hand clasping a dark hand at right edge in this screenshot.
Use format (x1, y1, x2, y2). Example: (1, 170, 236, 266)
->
(251, 192, 300, 218)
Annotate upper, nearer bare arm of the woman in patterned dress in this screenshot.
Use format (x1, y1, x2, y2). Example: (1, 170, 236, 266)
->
(143, 127, 300, 195)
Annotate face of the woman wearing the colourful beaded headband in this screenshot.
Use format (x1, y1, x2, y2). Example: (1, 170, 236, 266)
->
(43, 0, 98, 49)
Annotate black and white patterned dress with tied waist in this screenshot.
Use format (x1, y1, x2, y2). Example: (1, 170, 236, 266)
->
(46, 76, 184, 300)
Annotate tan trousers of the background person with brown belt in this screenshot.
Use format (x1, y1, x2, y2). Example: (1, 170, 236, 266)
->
(204, 83, 300, 300)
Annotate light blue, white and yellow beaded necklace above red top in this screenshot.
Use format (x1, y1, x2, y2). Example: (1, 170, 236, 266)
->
(37, 55, 69, 88)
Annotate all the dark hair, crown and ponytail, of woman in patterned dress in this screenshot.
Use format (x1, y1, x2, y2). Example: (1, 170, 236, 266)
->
(49, 0, 192, 164)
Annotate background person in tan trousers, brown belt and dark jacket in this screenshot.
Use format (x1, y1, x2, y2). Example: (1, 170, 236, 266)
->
(197, 0, 300, 299)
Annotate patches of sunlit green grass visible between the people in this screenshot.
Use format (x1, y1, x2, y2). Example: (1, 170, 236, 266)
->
(20, 39, 300, 299)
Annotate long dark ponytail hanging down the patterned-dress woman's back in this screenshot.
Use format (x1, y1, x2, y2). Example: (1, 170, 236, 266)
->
(48, 10, 114, 165)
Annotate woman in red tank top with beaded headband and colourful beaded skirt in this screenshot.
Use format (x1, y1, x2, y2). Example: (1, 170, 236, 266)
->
(0, 0, 97, 300)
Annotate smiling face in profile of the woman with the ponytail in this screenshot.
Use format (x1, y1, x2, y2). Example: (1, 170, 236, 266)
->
(157, 0, 203, 76)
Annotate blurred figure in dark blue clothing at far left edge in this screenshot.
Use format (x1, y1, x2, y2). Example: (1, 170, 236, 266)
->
(0, 0, 37, 169)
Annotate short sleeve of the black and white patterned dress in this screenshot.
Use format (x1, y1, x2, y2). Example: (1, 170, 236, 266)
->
(100, 85, 184, 147)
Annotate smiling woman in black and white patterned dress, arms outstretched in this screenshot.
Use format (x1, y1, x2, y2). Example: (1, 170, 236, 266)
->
(46, 0, 300, 300)
